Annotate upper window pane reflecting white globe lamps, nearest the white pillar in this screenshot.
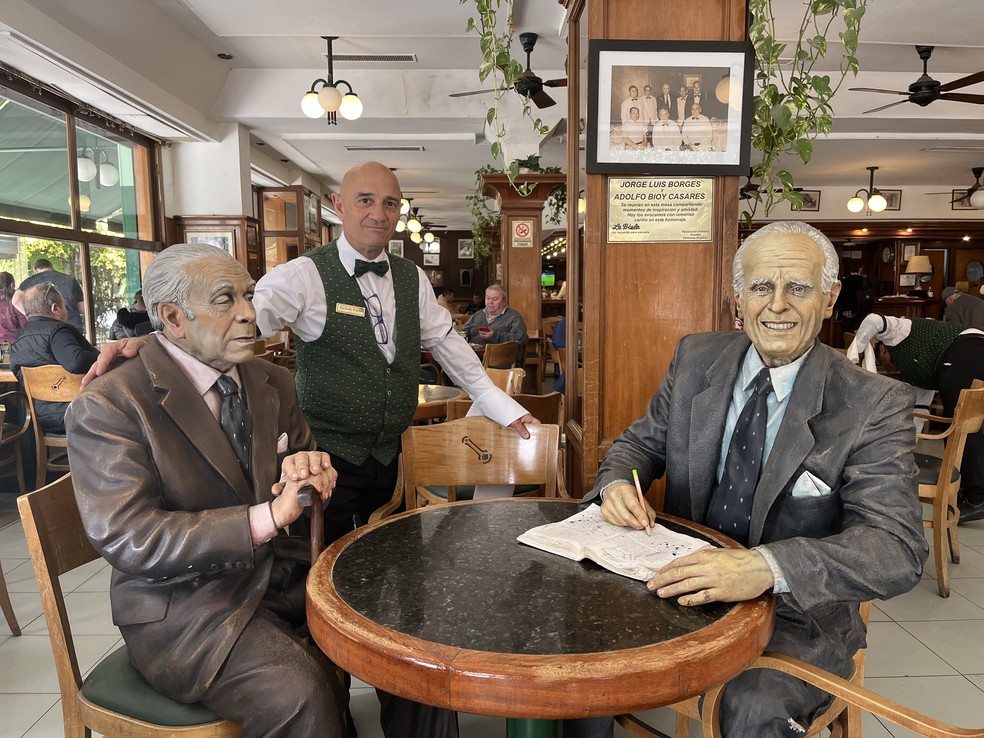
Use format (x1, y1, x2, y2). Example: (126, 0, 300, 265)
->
(75, 121, 153, 239)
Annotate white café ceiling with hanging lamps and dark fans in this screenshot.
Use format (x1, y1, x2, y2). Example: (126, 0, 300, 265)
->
(0, 0, 984, 228)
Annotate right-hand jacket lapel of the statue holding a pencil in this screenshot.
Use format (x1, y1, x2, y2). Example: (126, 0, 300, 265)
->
(748, 343, 830, 546)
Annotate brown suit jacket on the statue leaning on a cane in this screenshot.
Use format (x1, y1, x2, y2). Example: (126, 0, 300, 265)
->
(66, 337, 315, 701)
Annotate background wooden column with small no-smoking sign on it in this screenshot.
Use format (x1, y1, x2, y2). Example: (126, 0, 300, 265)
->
(482, 174, 567, 336)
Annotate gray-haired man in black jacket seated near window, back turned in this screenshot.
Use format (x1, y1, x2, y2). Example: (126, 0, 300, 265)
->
(10, 282, 99, 433)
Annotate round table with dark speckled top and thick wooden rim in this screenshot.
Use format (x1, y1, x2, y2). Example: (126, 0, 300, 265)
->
(307, 498, 773, 735)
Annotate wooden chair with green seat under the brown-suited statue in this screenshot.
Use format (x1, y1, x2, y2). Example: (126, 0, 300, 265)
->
(17, 474, 242, 738)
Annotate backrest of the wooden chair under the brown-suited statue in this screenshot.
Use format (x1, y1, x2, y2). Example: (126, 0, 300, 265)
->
(17, 474, 99, 710)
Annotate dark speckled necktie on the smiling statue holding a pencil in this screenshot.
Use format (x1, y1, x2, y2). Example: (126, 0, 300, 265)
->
(707, 367, 772, 545)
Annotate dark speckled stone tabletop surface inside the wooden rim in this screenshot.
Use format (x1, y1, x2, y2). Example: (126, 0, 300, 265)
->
(332, 501, 734, 654)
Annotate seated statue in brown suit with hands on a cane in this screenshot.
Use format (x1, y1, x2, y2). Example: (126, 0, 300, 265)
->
(66, 244, 347, 738)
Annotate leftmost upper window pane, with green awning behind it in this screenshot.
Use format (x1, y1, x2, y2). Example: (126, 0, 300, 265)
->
(0, 86, 72, 228)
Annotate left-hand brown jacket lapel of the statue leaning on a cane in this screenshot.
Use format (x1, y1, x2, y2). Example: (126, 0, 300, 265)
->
(140, 337, 256, 504)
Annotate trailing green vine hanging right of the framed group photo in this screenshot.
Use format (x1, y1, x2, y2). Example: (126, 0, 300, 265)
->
(741, 0, 868, 226)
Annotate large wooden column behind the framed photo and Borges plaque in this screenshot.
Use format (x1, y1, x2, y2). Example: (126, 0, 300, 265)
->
(567, 0, 745, 496)
